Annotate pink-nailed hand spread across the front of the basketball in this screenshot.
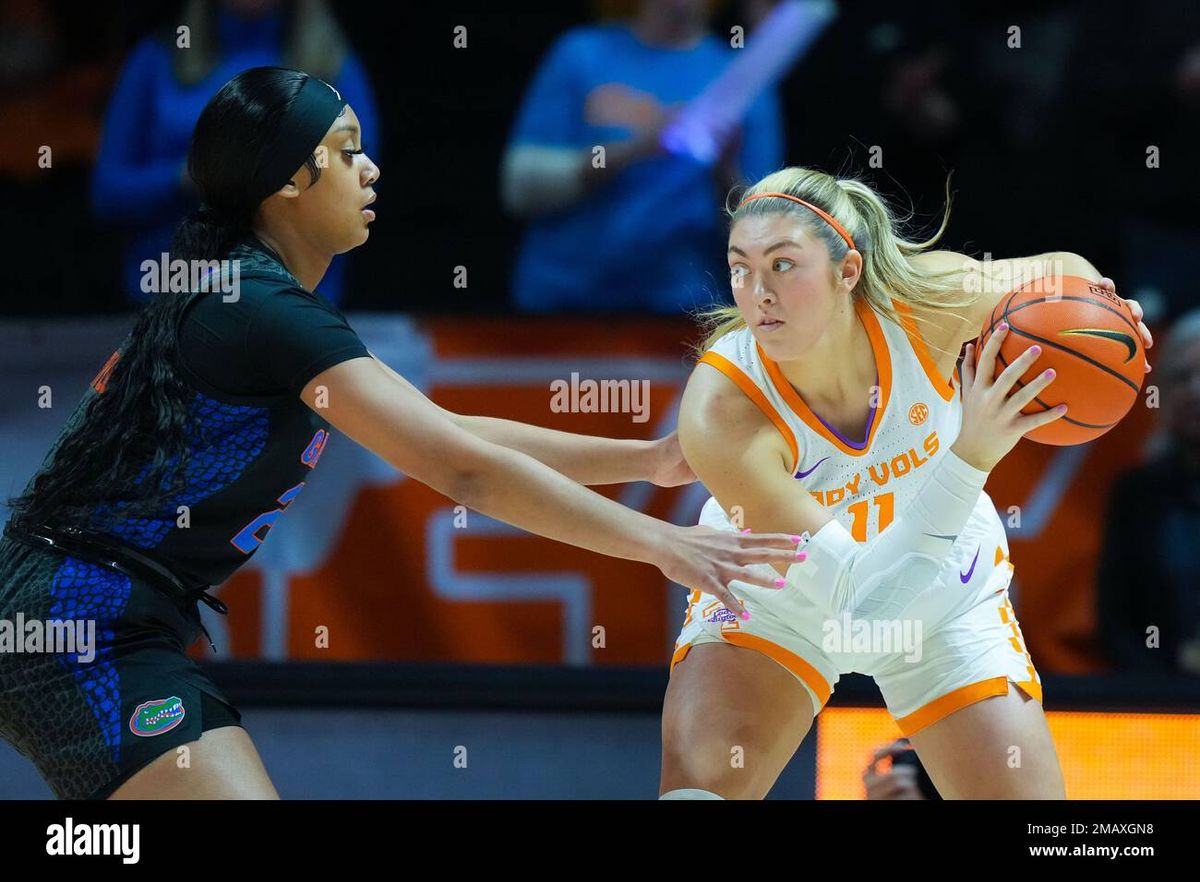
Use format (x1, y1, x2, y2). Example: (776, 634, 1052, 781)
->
(950, 323, 1066, 472)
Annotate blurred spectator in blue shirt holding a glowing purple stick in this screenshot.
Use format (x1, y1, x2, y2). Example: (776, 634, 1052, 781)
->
(502, 0, 784, 313)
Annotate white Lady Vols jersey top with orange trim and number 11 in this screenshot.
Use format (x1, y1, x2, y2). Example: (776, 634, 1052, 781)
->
(700, 299, 1010, 604)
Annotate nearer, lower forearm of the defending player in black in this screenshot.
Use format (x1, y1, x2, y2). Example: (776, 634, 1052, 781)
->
(454, 444, 678, 564)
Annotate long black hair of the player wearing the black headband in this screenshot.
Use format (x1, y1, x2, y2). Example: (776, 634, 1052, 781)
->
(8, 67, 331, 527)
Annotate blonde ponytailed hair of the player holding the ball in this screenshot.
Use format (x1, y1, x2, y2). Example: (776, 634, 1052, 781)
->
(696, 167, 979, 354)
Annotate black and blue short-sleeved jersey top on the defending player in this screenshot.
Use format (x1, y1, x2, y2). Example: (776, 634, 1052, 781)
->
(18, 236, 370, 584)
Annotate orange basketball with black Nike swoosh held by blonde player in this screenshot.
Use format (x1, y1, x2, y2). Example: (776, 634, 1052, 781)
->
(976, 276, 1146, 445)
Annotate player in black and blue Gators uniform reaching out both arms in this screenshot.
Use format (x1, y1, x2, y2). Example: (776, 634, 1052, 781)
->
(0, 67, 798, 799)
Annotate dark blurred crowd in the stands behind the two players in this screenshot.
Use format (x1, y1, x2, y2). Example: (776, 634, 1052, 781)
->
(0, 0, 1200, 674)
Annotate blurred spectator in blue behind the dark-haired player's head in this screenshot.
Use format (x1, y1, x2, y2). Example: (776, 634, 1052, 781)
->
(91, 0, 379, 307)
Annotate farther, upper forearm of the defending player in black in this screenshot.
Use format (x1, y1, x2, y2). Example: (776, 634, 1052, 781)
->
(451, 414, 655, 485)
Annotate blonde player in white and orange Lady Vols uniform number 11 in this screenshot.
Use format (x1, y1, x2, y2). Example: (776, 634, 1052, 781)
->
(660, 168, 1152, 799)
